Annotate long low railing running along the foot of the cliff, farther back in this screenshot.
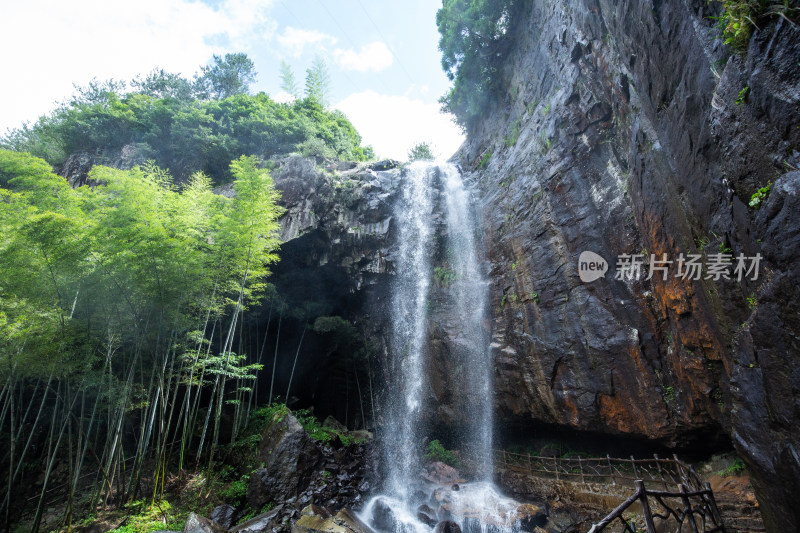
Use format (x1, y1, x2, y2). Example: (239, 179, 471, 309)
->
(494, 450, 704, 491)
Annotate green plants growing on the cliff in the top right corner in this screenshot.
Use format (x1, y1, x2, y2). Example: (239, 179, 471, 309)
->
(715, 0, 798, 51)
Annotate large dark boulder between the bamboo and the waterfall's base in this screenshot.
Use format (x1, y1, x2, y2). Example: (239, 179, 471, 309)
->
(247, 411, 322, 509)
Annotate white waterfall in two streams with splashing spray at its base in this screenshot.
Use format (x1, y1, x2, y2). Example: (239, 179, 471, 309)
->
(361, 162, 536, 533)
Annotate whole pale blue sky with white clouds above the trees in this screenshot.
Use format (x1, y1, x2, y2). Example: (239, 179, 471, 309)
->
(0, 0, 464, 160)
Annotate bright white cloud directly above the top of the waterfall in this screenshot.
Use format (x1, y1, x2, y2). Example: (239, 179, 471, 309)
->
(334, 91, 464, 161)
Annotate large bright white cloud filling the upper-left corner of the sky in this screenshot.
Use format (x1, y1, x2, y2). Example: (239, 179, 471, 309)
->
(0, 0, 275, 132)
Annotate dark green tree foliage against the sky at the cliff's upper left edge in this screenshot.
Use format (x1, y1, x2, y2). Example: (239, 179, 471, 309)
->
(436, 0, 524, 129)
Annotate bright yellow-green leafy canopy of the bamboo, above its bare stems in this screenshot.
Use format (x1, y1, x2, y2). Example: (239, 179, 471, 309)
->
(0, 150, 281, 394)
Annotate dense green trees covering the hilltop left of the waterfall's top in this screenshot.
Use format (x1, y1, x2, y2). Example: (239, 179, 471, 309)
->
(0, 57, 374, 183)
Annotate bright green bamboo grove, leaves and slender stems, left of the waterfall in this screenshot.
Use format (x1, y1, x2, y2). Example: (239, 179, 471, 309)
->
(0, 150, 281, 530)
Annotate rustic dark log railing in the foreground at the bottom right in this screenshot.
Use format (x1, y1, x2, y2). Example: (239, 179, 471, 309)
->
(589, 480, 725, 533)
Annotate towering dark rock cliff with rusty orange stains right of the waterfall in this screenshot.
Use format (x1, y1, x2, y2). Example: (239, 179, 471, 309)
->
(456, 0, 800, 529)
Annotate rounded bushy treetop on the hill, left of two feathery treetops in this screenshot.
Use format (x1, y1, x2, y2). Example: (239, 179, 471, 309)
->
(195, 52, 256, 99)
